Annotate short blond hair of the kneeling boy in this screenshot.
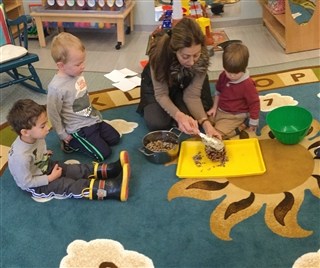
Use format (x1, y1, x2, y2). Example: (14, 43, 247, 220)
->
(51, 32, 85, 63)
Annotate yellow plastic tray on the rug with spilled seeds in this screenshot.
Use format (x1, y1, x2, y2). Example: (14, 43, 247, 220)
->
(176, 138, 266, 178)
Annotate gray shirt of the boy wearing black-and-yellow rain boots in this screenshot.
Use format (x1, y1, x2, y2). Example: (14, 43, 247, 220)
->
(8, 137, 49, 190)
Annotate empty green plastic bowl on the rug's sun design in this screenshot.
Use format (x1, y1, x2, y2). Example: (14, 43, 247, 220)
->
(267, 106, 312, 144)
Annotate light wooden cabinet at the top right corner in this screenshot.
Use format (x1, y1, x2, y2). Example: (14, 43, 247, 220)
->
(260, 0, 320, 53)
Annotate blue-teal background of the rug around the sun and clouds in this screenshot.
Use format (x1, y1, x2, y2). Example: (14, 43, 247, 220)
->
(0, 79, 320, 268)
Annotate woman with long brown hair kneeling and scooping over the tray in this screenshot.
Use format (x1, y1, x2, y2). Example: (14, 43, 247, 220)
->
(137, 17, 221, 138)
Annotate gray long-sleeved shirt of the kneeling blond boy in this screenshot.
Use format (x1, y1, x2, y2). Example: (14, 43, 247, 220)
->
(47, 74, 102, 140)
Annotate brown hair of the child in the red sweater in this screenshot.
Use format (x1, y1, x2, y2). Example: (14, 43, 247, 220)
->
(222, 43, 249, 74)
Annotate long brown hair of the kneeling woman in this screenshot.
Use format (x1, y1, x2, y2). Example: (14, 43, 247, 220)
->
(148, 17, 208, 81)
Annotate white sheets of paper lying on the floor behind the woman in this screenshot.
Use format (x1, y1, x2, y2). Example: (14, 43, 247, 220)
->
(104, 68, 141, 92)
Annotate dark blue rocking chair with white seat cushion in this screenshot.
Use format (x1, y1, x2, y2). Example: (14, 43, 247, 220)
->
(0, 5, 47, 94)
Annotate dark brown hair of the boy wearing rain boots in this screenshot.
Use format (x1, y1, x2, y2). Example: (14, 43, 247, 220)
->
(7, 99, 46, 136)
